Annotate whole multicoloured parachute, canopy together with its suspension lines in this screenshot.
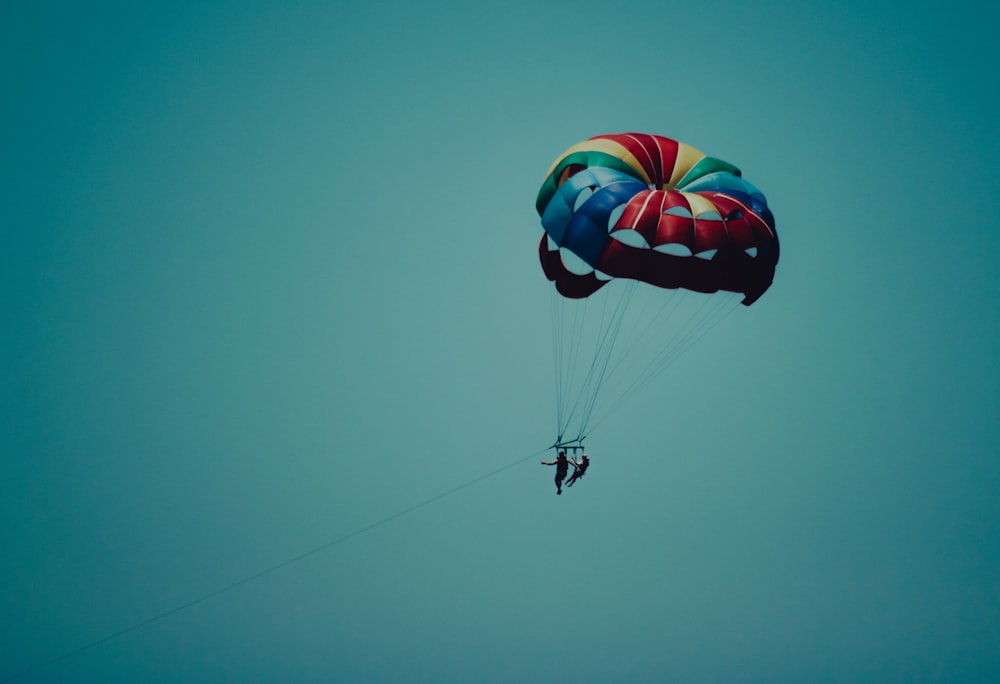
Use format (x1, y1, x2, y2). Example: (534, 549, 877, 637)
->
(535, 133, 779, 446)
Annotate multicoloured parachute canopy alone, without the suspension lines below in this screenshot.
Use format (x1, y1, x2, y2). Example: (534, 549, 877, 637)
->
(535, 133, 779, 306)
